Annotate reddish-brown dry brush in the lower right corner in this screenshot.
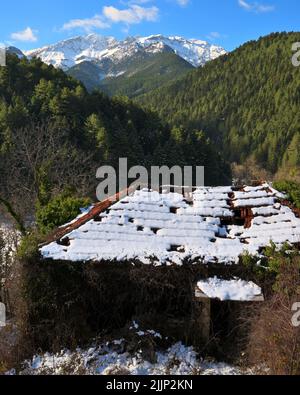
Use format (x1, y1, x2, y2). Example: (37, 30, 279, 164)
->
(248, 256, 300, 375)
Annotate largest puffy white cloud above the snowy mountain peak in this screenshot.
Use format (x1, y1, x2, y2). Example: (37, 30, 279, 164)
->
(103, 5, 159, 25)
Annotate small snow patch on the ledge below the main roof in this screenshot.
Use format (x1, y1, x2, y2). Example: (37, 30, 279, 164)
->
(197, 277, 262, 302)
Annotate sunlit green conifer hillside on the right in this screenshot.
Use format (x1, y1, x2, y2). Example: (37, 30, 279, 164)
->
(137, 33, 300, 177)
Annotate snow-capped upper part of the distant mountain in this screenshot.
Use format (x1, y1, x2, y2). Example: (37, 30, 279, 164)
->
(25, 33, 226, 70)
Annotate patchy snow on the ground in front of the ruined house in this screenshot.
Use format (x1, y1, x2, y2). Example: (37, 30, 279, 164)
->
(7, 339, 254, 376)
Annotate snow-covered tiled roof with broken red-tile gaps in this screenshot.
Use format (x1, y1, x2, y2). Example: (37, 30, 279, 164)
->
(41, 184, 300, 266)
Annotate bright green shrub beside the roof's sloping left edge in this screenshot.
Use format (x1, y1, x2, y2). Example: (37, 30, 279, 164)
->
(36, 193, 91, 234)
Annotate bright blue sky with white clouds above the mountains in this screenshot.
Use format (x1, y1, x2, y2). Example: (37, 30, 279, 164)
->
(0, 0, 300, 50)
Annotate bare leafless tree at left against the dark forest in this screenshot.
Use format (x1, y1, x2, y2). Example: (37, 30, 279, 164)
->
(0, 121, 96, 231)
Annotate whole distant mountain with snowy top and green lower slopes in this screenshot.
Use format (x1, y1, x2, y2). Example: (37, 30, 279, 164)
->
(25, 33, 226, 97)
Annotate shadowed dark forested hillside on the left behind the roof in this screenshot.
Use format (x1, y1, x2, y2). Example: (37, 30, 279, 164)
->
(0, 55, 230, 230)
